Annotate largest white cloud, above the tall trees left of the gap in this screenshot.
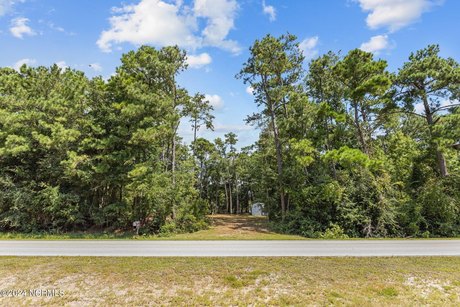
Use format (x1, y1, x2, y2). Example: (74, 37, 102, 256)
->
(97, 0, 240, 53)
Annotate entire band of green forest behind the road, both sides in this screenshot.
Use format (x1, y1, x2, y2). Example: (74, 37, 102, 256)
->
(0, 34, 460, 237)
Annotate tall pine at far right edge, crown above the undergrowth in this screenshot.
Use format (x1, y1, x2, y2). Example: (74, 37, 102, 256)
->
(394, 45, 460, 177)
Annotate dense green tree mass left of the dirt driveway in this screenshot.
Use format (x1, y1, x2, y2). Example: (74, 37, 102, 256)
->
(0, 46, 212, 232)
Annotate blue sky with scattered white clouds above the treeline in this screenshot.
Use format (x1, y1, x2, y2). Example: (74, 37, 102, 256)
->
(0, 0, 460, 146)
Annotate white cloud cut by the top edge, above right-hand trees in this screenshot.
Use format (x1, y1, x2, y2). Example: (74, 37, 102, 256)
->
(355, 0, 443, 32)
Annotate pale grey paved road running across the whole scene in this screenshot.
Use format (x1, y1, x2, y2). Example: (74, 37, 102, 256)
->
(0, 240, 460, 257)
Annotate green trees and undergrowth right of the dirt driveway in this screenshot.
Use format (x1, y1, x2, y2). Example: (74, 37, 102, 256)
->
(237, 37, 460, 238)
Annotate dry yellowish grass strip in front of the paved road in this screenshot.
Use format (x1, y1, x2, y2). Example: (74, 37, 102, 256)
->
(0, 257, 460, 306)
